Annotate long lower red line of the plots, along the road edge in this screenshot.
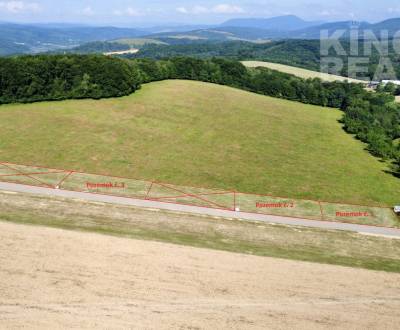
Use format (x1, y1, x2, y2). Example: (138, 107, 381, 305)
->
(3, 177, 400, 230)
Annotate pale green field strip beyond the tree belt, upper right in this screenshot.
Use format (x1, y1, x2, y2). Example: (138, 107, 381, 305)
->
(242, 61, 366, 84)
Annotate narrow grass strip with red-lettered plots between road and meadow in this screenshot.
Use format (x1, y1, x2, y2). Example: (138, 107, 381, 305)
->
(0, 164, 400, 227)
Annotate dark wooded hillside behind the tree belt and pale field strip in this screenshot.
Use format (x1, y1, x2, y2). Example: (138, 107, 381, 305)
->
(129, 40, 400, 80)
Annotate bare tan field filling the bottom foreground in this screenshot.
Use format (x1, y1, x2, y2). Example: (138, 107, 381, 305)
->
(0, 222, 400, 329)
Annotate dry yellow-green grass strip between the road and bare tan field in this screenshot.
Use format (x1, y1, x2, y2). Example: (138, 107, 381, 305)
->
(0, 192, 400, 273)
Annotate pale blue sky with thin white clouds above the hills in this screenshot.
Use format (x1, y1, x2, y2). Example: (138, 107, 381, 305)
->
(0, 0, 400, 26)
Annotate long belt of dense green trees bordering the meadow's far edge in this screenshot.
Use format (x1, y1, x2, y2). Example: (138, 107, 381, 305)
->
(0, 55, 400, 174)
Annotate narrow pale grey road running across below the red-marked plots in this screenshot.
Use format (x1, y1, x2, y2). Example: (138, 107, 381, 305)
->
(0, 182, 400, 238)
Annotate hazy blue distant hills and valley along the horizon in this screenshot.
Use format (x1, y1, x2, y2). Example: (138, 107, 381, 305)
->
(0, 15, 400, 56)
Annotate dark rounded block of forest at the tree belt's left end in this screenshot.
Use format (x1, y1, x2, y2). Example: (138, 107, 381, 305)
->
(0, 55, 140, 104)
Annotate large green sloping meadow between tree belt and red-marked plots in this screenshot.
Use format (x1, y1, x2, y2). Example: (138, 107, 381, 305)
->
(0, 80, 400, 206)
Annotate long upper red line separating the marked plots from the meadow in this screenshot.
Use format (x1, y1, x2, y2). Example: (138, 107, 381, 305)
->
(0, 162, 391, 209)
